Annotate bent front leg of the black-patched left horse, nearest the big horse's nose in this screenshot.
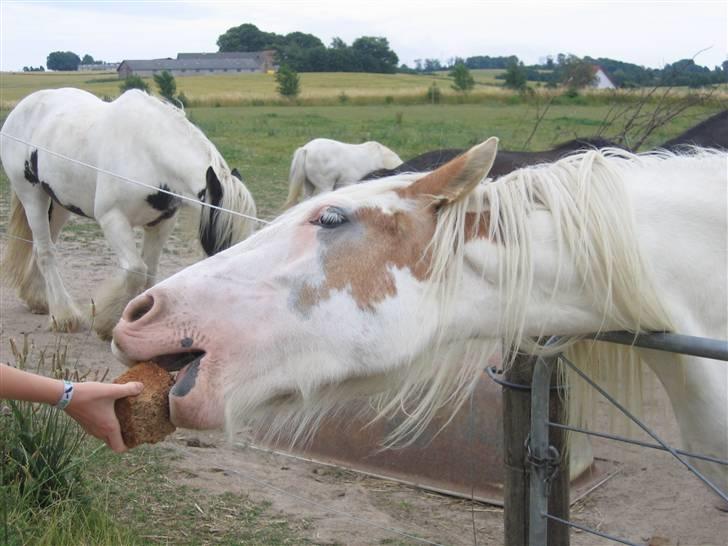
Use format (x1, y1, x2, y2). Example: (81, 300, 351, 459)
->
(93, 209, 147, 339)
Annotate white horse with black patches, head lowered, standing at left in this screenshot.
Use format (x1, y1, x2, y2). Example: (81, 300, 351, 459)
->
(0, 89, 255, 337)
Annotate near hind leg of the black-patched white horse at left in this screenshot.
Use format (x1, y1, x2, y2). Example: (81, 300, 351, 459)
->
(19, 197, 85, 332)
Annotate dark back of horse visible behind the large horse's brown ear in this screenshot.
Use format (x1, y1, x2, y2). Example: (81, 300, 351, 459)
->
(362, 137, 622, 181)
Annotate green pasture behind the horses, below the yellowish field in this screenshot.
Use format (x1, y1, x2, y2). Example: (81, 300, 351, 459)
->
(183, 101, 716, 217)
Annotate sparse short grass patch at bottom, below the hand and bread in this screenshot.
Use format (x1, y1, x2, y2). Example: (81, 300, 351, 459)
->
(89, 446, 312, 545)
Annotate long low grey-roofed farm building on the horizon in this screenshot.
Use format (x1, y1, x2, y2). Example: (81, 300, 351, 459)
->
(117, 50, 275, 78)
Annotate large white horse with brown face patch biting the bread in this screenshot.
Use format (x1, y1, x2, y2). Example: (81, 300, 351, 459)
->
(113, 139, 728, 498)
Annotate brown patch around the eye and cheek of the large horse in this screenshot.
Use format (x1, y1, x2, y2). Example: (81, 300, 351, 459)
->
(295, 208, 435, 313)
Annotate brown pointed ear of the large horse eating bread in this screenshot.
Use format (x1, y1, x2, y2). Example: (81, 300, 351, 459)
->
(405, 137, 498, 203)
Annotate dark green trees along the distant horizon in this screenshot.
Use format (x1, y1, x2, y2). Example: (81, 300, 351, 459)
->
(41, 23, 728, 88)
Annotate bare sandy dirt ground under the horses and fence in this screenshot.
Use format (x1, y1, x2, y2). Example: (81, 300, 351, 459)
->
(0, 214, 728, 546)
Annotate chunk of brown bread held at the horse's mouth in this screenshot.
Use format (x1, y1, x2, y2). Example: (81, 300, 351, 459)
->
(114, 362, 175, 448)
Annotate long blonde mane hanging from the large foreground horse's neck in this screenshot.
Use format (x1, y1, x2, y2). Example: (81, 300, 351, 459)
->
(378, 149, 684, 442)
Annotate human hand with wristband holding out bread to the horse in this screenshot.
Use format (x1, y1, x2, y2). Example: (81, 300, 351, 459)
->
(64, 381, 144, 453)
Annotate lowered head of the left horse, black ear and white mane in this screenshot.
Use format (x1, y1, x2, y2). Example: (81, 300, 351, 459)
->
(199, 167, 257, 256)
